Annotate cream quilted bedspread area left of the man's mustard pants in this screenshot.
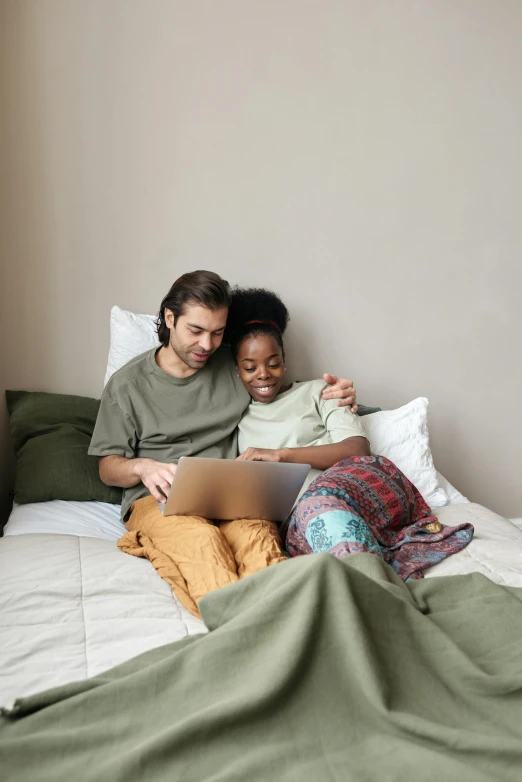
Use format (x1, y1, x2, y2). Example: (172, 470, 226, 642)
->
(0, 534, 206, 706)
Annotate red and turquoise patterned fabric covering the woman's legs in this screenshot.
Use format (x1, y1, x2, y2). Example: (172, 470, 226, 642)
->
(286, 456, 474, 581)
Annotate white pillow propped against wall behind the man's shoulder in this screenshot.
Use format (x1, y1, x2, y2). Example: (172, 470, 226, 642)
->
(104, 307, 159, 385)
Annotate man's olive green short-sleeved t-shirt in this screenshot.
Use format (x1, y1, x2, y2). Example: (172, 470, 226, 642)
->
(89, 346, 250, 519)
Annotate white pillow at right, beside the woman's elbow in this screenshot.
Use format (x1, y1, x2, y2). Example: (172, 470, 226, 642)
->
(361, 397, 449, 508)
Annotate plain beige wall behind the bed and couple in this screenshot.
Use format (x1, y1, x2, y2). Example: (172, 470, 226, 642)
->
(0, 0, 522, 515)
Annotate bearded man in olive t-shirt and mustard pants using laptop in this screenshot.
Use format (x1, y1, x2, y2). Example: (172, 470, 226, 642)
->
(89, 271, 355, 615)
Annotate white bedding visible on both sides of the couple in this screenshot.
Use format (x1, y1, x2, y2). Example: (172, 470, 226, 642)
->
(0, 475, 522, 706)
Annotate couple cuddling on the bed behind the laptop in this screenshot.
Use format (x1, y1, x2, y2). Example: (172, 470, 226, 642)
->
(89, 271, 472, 616)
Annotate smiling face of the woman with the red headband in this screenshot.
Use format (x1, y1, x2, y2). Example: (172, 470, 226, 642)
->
(236, 334, 285, 402)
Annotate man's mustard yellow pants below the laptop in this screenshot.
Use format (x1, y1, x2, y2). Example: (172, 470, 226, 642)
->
(118, 497, 286, 617)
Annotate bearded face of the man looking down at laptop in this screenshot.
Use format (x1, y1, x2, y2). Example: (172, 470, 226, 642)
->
(165, 304, 228, 369)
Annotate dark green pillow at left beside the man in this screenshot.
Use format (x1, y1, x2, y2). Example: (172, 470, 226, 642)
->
(5, 391, 122, 505)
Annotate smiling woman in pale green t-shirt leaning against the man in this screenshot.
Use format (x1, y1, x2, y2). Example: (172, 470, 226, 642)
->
(228, 288, 473, 580)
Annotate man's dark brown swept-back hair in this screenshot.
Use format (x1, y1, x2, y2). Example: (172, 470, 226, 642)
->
(156, 270, 231, 346)
